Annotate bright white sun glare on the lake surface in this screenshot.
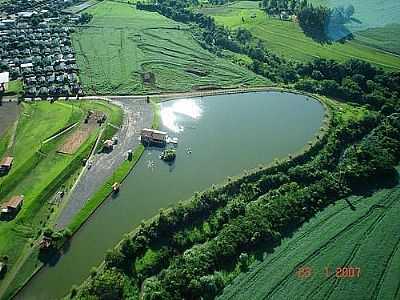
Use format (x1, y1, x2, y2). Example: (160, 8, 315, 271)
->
(160, 99, 203, 133)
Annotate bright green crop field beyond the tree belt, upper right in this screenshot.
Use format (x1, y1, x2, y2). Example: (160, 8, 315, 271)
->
(202, 1, 400, 70)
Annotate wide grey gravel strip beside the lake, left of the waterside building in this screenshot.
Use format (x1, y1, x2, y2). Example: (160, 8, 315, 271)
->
(56, 97, 153, 229)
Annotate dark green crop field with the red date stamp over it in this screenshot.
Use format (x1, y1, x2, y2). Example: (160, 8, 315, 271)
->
(219, 186, 400, 300)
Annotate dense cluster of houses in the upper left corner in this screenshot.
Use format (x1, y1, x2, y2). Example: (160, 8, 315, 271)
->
(0, 0, 86, 99)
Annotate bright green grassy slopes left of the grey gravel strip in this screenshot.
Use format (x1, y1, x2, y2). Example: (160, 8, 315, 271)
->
(0, 101, 121, 297)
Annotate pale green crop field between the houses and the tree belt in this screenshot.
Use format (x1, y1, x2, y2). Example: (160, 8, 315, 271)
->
(73, 1, 266, 94)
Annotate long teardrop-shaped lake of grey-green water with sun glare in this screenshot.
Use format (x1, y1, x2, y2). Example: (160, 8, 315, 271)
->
(17, 92, 324, 300)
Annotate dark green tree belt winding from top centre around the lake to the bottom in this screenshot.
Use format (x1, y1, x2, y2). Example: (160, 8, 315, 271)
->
(67, 0, 400, 300)
